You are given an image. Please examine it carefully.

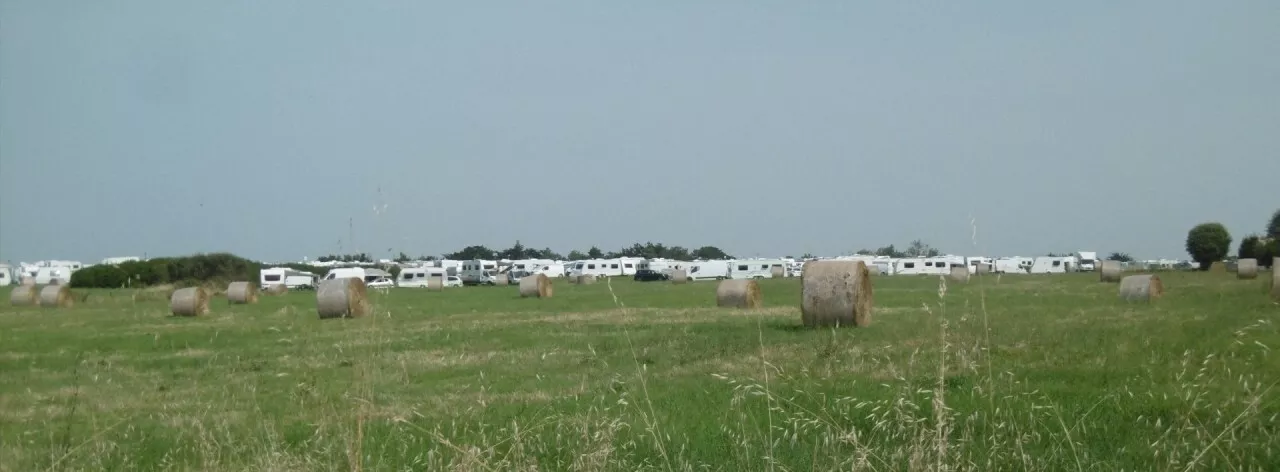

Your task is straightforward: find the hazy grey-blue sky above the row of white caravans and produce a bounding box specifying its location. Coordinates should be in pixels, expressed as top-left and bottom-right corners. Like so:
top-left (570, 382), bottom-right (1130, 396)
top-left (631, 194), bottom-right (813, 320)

top-left (0, 0), bottom-right (1280, 262)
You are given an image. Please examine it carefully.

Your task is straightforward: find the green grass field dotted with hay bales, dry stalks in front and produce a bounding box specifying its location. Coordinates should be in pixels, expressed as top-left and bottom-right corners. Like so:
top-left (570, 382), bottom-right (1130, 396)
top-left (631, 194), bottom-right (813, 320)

top-left (0, 272), bottom-right (1280, 471)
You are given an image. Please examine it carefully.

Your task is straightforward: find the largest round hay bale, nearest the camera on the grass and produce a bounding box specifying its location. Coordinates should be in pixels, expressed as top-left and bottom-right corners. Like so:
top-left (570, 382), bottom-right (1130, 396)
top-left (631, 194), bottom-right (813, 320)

top-left (800, 261), bottom-right (876, 326)
